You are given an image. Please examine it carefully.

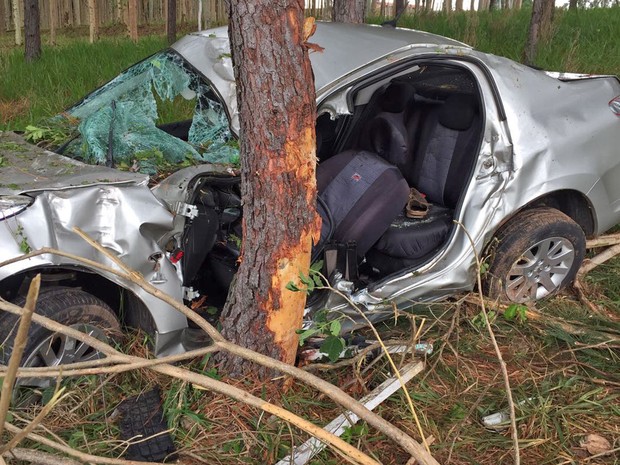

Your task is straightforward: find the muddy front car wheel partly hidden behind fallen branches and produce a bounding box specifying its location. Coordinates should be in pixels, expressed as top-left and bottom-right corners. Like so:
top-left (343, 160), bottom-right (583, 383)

top-left (0, 288), bottom-right (121, 406)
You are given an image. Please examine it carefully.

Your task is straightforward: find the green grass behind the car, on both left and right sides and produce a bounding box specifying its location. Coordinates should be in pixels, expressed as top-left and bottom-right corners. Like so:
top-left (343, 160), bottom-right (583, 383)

top-left (0, 7), bottom-right (620, 130)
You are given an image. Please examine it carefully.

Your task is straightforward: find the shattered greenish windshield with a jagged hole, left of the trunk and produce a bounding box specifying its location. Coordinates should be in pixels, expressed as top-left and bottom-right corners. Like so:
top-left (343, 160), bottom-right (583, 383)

top-left (58, 50), bottom-right (239, 175)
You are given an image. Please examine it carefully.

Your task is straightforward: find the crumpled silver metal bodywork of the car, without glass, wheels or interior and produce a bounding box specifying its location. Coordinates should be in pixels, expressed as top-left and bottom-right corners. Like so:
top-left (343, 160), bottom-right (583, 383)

top-left (0, 23), bottom-right (620, 348)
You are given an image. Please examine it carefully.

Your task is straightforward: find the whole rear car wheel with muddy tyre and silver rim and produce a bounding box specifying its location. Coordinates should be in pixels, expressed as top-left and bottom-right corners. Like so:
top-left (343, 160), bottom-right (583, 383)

top-left (483, 207), bottom-right (586, 303)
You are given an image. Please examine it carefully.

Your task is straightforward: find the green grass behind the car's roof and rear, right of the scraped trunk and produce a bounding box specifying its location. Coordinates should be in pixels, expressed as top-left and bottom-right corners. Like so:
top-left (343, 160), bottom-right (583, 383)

top-left (371, 7), bottom-right (620, 75)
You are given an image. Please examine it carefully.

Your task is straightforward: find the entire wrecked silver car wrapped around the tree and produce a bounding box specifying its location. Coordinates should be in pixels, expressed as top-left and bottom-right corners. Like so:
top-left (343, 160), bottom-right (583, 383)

top-left (0, 23), bottom-right (620, 392)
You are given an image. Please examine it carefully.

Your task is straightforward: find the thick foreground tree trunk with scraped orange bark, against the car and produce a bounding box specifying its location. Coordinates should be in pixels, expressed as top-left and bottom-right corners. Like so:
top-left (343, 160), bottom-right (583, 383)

top-left (217, 0), bottom-right (320, 379)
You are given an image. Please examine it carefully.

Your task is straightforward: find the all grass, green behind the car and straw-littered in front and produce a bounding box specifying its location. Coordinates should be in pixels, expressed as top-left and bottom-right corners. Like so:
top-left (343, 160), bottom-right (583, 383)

top-left (0, 8), bottom-right (620, 465)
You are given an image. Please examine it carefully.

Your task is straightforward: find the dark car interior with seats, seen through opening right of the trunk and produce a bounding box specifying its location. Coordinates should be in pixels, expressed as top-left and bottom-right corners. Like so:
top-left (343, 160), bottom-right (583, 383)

top-left (317, 64), bottom-right (483, 281)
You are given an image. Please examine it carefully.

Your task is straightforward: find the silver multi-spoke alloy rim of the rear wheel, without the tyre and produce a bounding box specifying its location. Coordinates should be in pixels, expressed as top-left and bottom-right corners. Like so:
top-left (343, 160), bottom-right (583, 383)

top-left (506, 237), bottom-right (575, 303)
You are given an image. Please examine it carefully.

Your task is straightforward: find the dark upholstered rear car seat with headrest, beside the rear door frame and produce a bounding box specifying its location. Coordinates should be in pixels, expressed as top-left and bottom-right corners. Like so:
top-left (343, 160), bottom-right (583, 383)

top-left (367, 94), bottom-right (482, 274)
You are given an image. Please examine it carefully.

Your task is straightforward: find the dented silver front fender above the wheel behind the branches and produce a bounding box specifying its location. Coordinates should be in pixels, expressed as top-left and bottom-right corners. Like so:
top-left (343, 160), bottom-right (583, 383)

top-left (0, 184), bottom-right (187, 353)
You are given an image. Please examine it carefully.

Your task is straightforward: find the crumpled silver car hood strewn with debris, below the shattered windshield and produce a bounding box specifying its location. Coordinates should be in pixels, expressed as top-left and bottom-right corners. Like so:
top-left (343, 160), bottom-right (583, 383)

top-left (0, 132), bottom-right (148, 195)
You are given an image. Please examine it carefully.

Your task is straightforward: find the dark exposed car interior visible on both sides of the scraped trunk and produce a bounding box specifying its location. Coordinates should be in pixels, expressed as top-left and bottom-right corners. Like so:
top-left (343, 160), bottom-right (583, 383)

top-left (183, 60), bottom-right (483, 306)
